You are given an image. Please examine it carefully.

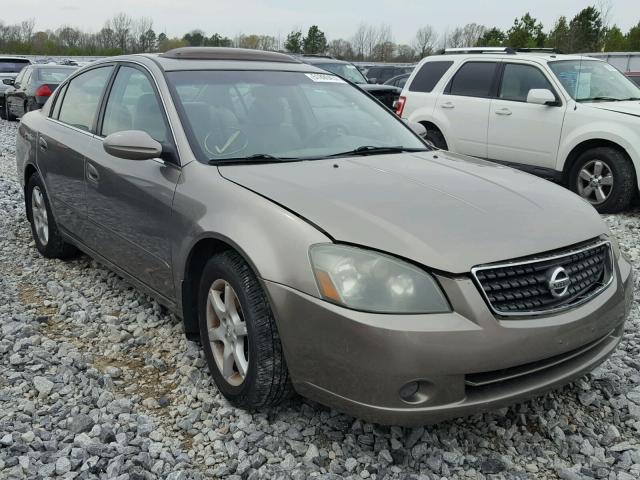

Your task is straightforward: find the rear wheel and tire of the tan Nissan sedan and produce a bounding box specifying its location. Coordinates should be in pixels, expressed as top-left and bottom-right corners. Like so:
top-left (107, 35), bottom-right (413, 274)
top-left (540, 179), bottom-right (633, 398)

top-left (25, 173), bottom-right (78, 258)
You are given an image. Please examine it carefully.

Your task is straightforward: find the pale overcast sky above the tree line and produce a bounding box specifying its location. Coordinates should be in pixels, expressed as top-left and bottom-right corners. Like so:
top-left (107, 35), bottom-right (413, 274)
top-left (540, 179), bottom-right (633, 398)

top-left (1, 0), bottom-right (640, 43)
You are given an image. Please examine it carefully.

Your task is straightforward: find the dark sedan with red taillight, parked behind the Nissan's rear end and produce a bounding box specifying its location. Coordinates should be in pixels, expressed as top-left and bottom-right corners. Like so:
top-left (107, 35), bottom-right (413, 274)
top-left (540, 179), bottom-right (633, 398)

top-left (3, 65), bottom-right (78, 120)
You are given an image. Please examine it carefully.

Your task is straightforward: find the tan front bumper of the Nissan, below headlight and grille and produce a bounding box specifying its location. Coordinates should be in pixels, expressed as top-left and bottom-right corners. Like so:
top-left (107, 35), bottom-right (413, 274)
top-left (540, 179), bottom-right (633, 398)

top-left (265, 258), bottom-right (633, 425)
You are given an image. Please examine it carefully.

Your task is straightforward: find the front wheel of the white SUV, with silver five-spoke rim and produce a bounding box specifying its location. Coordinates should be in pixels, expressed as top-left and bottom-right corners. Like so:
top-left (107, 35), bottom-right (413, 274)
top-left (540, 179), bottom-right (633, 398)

top-left (570, 147), bottom-right (636, 213)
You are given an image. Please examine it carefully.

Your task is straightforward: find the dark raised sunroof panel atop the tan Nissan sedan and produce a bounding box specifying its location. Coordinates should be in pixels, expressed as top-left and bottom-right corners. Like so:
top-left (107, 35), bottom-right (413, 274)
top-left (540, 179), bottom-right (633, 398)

top-left (158, 47), bottom-right (300, 63)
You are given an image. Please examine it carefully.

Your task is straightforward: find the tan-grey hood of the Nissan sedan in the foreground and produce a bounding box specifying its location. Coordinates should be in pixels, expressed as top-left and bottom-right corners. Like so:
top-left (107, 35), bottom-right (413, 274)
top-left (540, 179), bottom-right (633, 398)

top-left (219, 151), bottom-right (608, 273)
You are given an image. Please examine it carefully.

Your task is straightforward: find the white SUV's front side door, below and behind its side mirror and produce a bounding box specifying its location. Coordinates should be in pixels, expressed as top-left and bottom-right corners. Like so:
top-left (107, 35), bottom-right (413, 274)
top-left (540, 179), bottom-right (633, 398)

top-left (488, 62), bottom-right (567, 168)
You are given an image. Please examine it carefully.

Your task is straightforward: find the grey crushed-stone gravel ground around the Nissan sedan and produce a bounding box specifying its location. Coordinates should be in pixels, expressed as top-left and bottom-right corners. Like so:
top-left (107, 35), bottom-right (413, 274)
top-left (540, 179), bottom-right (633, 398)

top-left (0, 117), bottom-right (640, 480)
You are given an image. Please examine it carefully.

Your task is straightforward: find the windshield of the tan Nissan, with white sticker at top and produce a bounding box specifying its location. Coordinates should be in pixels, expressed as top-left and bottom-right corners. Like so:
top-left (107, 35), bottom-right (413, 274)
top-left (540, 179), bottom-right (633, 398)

top-left (168, 70), bottom-right (427, 161)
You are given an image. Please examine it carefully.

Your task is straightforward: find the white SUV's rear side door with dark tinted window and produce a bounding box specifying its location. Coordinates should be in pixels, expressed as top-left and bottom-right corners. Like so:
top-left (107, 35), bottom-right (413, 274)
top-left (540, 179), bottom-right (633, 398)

top-left (433, 60), bottom-right (498, 158)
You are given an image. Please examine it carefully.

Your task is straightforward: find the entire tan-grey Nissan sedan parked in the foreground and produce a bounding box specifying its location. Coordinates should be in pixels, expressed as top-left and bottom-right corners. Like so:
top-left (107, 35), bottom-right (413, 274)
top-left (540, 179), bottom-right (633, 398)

top-left (16, 48), bottom-right (632, 425)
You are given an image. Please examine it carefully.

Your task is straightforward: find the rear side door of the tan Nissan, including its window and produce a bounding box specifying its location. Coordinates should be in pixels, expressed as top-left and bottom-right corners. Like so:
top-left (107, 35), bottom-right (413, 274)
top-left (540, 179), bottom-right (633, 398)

top-left (37, 66), bottom-right (113, 240)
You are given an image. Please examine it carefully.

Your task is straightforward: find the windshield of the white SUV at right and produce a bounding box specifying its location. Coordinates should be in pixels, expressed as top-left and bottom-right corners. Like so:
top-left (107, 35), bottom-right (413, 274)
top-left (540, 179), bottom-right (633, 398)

top-left (549, 60), bottom-right (640, 102)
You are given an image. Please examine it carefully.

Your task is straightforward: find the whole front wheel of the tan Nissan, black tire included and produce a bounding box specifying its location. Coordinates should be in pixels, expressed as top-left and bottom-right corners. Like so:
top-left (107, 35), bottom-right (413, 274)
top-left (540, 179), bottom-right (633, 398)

top-left (198, 251), bottom-right (290, 408)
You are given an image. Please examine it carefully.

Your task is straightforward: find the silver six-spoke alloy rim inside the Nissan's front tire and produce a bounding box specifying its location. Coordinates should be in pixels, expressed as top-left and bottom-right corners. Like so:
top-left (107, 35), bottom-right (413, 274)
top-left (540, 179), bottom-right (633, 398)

top-left (207, 279), bottom-right (249, 386)
